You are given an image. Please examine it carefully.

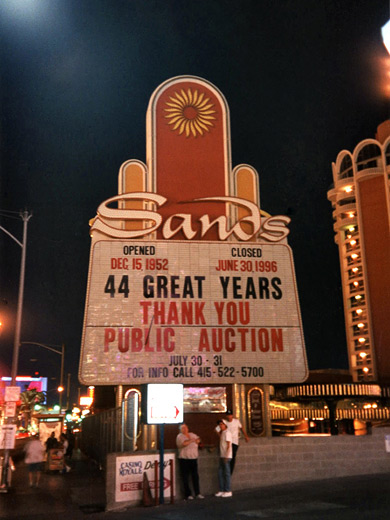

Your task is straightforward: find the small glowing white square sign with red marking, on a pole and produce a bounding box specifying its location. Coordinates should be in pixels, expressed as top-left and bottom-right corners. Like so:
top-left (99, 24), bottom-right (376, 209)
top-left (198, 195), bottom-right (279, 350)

top-left (146, 384), bottom-right (184, 424)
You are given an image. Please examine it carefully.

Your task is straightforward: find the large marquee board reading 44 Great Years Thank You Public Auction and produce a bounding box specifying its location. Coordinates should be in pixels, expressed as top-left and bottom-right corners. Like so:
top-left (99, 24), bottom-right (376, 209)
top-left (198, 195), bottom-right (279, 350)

top-left (80, 239), bottom-right (307, 385)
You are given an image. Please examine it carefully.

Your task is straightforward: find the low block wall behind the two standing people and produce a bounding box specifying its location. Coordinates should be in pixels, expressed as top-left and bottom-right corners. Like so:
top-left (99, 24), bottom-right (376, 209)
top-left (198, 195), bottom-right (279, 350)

top-left (106, 428), bottom-right (390, 509)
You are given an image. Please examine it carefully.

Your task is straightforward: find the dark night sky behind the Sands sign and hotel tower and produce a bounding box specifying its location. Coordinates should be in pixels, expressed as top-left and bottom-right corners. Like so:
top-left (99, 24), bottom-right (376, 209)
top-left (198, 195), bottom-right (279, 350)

top-left (0, 0), bottom-right (390, 404)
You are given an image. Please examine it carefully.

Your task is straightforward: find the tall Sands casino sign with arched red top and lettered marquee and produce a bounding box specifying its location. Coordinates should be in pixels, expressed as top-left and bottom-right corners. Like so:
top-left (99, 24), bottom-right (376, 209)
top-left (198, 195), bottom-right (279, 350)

top-left (79, 76), bottom-right (307, 385)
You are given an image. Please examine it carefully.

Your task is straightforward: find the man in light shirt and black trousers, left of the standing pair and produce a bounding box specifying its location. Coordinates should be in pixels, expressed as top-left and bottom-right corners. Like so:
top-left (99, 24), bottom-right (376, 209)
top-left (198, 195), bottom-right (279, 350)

top-left (176, 423), bottom-right (204, 500)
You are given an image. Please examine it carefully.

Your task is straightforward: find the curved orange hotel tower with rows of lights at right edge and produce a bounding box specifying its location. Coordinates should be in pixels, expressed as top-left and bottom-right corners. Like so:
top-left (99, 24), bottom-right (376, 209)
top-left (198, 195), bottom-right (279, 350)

top-left (328, 120), bottom-right (390, 384)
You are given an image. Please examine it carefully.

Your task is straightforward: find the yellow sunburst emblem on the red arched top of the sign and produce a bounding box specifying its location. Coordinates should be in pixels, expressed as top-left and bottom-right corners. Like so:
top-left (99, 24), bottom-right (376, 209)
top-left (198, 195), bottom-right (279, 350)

top-left (164, 88), bottom-right (216, 137)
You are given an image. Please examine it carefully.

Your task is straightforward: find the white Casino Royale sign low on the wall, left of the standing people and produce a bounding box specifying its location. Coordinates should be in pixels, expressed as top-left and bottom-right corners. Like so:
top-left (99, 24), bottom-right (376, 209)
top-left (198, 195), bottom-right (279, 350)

top-left (115, 453), bottom-right (175, 502)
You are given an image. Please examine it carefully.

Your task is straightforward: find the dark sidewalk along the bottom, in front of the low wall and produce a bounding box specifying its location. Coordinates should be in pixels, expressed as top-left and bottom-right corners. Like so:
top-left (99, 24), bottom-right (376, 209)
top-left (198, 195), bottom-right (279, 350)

top-left (0, 451), bottom-right (390, 520)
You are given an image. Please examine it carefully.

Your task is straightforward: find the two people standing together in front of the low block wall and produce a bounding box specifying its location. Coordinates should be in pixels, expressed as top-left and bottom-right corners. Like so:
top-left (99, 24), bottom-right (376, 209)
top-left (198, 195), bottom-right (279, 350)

top-left (176, 410), bottom-right (249, 500)
